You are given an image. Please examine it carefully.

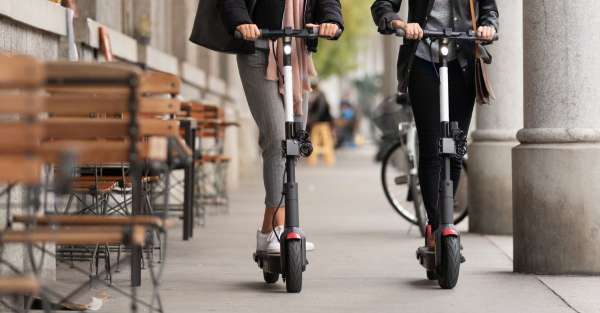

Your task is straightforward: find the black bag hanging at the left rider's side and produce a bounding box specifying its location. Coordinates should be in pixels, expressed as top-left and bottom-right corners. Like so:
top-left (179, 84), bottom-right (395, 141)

top-left (190, 0), bottom-right (254, 54)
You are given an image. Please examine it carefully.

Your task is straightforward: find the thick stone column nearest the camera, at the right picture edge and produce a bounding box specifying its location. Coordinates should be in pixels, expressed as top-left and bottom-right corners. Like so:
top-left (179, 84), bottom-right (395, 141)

top-left (513, 0), bottom-right (600, 274)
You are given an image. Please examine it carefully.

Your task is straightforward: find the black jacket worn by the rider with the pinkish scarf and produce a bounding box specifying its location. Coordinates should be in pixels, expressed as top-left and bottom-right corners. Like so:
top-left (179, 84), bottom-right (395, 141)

top-left (222, 0), bottom-right (344, 52)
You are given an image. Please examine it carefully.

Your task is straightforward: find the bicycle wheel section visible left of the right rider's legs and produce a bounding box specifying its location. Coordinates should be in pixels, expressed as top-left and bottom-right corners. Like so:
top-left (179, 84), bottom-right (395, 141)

top-left (381, 142), bottom-right (418, 225)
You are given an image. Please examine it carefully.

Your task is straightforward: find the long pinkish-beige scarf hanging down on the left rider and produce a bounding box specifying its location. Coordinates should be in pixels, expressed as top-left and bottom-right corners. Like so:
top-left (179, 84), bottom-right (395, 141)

top-left (266, 0), bottom-right (317, 116)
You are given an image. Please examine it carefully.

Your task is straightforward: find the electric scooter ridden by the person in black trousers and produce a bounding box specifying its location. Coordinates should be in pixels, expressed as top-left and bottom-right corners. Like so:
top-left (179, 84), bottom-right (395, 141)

top-left (396, 29), bottom-right (498, 289)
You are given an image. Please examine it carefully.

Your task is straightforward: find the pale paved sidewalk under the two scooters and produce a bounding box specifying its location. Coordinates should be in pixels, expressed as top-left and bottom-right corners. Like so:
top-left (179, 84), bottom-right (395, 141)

top-left (83, 146), bottom-right (600, 313)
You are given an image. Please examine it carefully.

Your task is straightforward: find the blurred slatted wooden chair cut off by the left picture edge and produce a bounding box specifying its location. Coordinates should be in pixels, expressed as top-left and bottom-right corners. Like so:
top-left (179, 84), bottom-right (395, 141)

top-left (0, 55), bottom-right (145, 308)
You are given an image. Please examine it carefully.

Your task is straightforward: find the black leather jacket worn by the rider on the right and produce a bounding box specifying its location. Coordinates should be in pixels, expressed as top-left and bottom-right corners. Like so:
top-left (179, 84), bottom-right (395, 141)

top-left (371, 0), bottom-right (499, 92)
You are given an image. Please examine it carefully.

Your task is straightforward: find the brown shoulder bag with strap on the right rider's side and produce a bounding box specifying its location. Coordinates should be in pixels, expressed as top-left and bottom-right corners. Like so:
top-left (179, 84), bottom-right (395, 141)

top-left (469, 0), bottom-right (496, 105)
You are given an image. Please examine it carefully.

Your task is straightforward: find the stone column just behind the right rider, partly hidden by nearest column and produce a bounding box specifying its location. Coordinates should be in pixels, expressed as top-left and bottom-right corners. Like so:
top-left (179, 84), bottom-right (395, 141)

top-left (468, 0), bottom-right (523, 234)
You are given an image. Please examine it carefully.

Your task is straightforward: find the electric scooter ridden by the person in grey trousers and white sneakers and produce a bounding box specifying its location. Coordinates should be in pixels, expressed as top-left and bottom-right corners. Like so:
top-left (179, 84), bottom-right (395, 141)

top-left (235, 28), bottom-right (339, 293)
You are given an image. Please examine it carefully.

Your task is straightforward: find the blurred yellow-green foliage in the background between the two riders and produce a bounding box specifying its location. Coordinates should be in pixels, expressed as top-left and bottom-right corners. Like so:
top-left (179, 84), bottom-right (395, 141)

top-left (314, 0), bottom-right (374, 78)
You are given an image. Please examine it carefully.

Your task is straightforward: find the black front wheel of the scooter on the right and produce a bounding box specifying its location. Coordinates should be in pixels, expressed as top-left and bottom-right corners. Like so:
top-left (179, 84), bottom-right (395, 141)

top-left (437, 237), bottom-right (460, 289)
